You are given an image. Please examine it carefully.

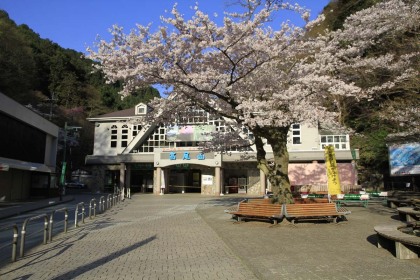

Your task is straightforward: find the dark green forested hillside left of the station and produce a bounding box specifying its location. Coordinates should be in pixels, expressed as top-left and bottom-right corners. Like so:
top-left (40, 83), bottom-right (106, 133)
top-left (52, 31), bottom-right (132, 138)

top-left (0, 10), bottom-right (159, 169)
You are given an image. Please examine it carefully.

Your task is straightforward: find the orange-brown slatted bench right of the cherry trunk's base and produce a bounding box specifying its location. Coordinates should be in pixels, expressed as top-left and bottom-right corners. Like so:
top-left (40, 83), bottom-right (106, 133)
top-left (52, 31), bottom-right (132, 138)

top-left (284, 203), bottom-right (351, 223)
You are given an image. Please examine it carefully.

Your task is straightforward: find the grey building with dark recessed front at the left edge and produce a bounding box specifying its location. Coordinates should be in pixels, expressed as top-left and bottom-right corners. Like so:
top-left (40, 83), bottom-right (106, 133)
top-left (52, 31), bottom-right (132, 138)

top-left (0, 93), bottom-right (59, 201)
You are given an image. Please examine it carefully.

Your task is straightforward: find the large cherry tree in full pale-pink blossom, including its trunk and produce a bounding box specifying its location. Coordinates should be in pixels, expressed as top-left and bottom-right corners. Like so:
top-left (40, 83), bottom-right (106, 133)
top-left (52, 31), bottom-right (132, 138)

top-left (88, 0), bottom-right (420, 203)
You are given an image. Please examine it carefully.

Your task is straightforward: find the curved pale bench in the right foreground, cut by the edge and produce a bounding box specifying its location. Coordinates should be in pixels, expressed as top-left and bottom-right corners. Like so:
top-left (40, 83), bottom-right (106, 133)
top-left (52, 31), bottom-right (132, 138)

top-left (374, 225), bottom-right (420, 260)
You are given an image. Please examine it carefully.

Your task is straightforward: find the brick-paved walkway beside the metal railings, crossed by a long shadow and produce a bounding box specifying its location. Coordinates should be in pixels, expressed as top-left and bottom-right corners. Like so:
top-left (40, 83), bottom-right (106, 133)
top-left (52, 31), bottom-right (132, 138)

top-left (0, 195), bottom-right (257, 279)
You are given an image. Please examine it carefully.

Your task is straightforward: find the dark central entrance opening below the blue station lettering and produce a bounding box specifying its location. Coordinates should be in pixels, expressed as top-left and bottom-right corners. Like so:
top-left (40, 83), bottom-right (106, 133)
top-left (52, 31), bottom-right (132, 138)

top-left (169, 169), bottom-right (201, 193)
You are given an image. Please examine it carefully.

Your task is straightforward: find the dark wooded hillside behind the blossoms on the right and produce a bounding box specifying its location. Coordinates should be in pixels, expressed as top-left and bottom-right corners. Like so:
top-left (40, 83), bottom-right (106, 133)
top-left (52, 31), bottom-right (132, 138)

top-left (312, 0), bottom-right (420, 185)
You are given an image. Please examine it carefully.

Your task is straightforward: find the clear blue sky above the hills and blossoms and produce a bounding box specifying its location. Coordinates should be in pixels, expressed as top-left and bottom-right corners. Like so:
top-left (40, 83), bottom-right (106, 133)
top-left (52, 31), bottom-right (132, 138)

top-left (0, 0), bottom-right (329, 52)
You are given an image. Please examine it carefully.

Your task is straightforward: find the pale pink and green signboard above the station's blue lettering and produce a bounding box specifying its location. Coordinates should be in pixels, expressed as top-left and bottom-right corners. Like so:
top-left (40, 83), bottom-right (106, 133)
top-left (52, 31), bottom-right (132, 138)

top-left (166, 125), bottom-right (216, 142)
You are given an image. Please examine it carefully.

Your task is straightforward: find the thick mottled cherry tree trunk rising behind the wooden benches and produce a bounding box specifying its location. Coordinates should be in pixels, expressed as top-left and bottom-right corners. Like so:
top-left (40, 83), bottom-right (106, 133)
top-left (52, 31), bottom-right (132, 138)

top-left (254, 127), bottom-right (293, 204)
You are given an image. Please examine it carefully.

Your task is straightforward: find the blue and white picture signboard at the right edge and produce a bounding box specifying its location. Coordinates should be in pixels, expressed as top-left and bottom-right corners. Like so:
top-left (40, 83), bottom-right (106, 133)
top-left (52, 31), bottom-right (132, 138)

top-left (388, 143), bottom-right (420, 176)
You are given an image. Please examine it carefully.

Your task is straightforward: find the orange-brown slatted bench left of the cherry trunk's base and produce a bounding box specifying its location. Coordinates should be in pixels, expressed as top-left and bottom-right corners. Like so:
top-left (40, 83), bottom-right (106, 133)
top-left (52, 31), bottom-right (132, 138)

top-left (229, 201), bottom-right (283, 224)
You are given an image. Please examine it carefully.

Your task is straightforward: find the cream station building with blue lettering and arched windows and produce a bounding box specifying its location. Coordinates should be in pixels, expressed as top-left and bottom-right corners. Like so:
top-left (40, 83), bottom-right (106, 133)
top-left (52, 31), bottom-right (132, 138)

top-left (86, 103), bottom-right (358, 195)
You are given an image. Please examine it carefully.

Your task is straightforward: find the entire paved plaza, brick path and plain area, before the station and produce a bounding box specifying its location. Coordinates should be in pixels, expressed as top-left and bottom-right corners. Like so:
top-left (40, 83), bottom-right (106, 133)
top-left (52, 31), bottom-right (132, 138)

top-left (0, 194), bottom-right (420, 279)
